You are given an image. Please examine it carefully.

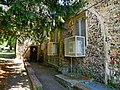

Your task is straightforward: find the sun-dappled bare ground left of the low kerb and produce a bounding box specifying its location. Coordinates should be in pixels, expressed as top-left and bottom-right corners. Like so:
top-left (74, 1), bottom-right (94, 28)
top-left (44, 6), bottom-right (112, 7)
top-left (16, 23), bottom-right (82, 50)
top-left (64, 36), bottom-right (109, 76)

top-left (0, 59), bottom-right (32, 90)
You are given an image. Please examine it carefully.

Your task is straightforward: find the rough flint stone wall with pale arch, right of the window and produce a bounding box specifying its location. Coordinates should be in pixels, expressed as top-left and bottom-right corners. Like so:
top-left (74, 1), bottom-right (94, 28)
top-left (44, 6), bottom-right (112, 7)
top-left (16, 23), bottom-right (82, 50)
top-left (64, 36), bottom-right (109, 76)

top-left (63, 0), bottom-right (120, 83)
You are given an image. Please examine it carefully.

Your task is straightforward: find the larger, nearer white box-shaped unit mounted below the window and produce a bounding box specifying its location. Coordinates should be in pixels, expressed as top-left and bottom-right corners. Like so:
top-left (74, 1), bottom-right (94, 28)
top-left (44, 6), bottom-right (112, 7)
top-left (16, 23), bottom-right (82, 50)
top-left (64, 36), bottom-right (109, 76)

top-left (65, 36), bottom-right (85, 57)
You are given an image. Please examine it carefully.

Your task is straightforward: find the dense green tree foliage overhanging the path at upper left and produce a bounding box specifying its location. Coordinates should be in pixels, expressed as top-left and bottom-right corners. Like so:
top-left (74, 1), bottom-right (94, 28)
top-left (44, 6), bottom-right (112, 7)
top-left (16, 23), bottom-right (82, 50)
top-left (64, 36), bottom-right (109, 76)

top-left (0, 0), bottom-right (85, 42)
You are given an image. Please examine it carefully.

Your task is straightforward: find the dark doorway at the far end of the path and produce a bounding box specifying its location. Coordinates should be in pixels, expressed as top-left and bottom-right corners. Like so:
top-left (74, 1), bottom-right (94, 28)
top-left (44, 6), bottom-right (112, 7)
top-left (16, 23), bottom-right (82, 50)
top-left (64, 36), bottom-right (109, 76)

top-left (30, 46), bottom-right (37, 62)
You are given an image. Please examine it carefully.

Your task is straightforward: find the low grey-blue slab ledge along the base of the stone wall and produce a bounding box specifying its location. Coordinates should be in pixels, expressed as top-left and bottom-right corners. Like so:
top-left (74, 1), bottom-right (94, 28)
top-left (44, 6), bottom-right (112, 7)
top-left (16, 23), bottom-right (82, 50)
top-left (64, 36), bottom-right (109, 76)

top-left (55, 74), bottom-right (115, 90)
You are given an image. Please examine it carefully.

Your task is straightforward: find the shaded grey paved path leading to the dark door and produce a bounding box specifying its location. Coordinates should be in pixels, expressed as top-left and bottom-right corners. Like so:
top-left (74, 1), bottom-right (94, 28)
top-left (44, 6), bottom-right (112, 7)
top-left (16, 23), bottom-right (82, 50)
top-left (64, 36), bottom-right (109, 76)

top-left (30, 63), bottom-right (67, 90)
